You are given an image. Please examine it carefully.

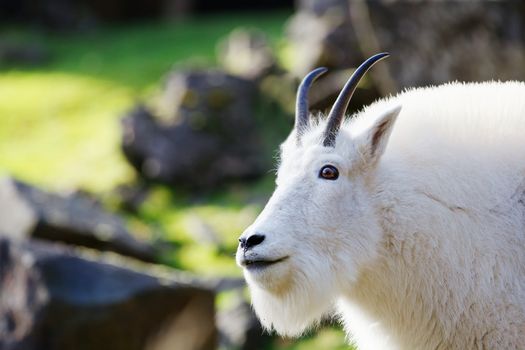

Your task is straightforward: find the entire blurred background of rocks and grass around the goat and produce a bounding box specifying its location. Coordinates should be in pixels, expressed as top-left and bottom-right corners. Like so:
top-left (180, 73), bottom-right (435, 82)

top-left (0, 0), bottom-right (525, 350)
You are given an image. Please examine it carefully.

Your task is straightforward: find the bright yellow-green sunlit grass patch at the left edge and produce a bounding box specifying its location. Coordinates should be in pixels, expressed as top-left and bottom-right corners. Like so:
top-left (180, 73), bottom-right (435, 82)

top-left (0, 72), bottom-right (133, 191)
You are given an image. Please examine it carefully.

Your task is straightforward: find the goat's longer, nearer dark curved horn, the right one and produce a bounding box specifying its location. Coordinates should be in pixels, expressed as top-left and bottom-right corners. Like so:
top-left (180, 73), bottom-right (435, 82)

top-left (323, 52), bottom-right (390, 147)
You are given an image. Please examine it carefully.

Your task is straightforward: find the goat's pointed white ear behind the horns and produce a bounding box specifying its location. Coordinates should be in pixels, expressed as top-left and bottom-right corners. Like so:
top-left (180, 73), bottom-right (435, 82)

top-left (358, 106), bottom-right (401, 166)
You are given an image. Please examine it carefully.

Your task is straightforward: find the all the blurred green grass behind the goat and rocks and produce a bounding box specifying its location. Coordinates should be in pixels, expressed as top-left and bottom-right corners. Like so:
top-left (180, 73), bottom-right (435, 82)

top-left (0, 13), bottom-right (352, 350)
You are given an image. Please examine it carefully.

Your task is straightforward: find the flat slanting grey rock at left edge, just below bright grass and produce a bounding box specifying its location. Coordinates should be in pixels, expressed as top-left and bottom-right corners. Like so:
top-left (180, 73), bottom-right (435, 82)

top-left (0, 178), bottom-right (155, 261)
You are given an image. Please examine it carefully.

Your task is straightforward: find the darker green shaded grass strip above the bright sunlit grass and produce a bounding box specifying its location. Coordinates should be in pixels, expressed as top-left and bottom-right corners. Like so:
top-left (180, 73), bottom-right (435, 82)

top-left (2, 12), bottom-right (290, 90)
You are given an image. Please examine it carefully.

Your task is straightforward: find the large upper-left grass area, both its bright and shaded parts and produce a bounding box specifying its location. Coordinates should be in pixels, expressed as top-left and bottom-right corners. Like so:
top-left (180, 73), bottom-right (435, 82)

top-left (0, 13), bottom-right (288, 192)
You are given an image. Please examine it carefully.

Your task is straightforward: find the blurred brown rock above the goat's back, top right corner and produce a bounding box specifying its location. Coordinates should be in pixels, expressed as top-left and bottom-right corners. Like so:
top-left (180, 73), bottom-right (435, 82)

top-left (357, 1), bottom-right (525, 89)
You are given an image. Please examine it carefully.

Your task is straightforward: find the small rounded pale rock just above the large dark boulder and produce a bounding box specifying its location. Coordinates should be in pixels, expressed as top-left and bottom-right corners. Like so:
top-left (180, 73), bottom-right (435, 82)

top-left (217, 29), bottom-right (276, 80)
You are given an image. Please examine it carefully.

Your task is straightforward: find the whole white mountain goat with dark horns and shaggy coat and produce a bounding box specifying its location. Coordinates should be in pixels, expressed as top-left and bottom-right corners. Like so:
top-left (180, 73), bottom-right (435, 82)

top-left (236, 54), bottom-right (525, 350)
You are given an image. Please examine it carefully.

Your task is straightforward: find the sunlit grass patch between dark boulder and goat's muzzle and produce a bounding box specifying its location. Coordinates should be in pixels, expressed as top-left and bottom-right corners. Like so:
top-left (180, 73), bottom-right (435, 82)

top-left (139, 185), bottom-right (272, 276)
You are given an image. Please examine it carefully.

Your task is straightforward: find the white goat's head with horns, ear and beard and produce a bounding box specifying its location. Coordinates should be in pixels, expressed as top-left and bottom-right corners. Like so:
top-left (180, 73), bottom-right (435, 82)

top-left (237, 53), bottom-right (400, 336)
